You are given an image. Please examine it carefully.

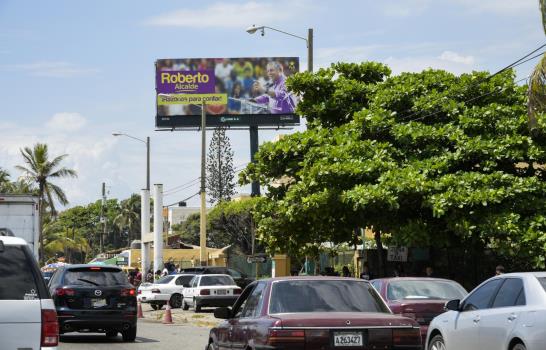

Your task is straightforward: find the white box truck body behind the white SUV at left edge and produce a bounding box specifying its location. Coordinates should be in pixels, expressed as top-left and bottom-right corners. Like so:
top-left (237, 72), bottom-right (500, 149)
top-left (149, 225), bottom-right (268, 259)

top-left (0, 193), bottom-right (40, 259)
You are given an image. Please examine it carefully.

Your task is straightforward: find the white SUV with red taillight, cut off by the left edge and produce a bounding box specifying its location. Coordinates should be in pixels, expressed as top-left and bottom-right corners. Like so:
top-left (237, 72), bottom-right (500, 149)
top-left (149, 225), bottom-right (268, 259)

top-left (0, 234), bottom-right (59, 350)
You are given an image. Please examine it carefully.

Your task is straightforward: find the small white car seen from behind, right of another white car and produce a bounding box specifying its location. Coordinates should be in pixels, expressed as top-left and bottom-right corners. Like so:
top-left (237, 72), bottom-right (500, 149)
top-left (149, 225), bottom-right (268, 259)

top-left (182, 274), bottom-right (242, 312)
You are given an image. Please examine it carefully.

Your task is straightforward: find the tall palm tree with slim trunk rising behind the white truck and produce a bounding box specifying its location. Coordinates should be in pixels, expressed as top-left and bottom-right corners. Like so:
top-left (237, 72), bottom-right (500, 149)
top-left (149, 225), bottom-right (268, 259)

top-left (16, 143), bottom-right (77, 263)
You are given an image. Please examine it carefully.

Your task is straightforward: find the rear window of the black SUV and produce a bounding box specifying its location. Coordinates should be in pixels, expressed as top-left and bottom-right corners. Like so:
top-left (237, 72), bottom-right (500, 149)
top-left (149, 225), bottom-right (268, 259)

top-left (64, 267), bottom-right (128, 286)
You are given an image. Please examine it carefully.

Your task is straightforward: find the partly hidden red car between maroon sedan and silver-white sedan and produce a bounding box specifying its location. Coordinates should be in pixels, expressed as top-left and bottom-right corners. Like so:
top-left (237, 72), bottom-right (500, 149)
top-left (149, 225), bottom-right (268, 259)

top-left (370, 277), bottom-right (468, 344)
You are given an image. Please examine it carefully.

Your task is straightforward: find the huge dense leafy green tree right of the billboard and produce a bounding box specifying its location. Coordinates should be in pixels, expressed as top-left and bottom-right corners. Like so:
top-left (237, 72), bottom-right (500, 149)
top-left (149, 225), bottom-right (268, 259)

top-left (241, 62), bottom-right (546, 267)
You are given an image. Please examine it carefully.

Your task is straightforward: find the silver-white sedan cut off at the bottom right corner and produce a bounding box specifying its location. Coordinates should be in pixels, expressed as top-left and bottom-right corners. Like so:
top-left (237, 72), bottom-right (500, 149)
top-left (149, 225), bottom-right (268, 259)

top-left (427, 272), bottom-right (546, 350)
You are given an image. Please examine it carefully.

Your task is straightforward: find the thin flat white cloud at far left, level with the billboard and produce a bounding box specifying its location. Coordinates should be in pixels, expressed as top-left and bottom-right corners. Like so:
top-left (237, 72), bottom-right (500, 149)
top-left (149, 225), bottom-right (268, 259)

top-left (3, 62), bottom-right (99, 78)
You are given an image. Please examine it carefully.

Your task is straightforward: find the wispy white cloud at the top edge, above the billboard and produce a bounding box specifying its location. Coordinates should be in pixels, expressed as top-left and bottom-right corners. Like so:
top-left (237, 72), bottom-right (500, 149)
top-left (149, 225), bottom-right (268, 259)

top-left (145, 0), bottom-right (317, 28)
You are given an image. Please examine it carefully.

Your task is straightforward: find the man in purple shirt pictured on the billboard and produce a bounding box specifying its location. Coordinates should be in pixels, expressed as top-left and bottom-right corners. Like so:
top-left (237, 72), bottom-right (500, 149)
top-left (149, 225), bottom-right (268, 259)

top-left (250, 61), bottom-right (297, 114)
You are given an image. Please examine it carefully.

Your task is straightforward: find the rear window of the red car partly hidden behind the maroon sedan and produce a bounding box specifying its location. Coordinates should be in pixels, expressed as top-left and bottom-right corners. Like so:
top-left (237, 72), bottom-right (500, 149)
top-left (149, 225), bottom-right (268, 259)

top-left (387, 280), bottom-right (467, 300)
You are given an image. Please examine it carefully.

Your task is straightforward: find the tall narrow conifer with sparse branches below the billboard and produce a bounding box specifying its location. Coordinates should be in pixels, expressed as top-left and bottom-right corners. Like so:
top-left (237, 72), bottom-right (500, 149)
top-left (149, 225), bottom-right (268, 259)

top-left (207, 127), bottom-right (235, 203)
